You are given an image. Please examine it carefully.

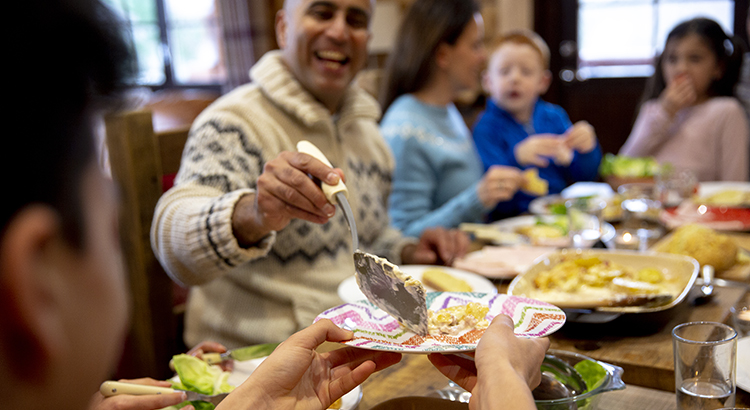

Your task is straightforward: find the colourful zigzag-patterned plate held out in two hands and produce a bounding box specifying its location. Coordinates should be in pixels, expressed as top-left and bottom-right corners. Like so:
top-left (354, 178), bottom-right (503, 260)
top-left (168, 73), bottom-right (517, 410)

top-left (315, 292), bottom-right (565, 353)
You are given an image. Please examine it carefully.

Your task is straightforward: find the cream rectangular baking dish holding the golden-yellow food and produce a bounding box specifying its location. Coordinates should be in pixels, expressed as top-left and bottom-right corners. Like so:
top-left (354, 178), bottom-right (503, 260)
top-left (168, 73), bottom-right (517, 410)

top-left (508, 249), bottom-right (699, 313)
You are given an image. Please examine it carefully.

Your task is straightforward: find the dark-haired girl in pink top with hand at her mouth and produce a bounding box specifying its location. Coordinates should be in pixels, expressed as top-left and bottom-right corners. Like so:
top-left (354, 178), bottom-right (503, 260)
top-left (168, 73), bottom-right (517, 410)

top-left (620, 18), bottom-right (750, 181)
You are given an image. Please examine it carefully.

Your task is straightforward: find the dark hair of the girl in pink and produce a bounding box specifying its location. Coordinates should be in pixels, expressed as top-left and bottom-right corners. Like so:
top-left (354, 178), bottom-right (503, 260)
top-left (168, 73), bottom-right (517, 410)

top-left (641, 17), bottom-right (745, 103)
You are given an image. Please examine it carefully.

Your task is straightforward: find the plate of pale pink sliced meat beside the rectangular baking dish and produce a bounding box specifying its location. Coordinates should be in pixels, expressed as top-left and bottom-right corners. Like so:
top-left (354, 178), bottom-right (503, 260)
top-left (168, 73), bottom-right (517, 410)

top-left (453, 245), bottom-right (557, 279)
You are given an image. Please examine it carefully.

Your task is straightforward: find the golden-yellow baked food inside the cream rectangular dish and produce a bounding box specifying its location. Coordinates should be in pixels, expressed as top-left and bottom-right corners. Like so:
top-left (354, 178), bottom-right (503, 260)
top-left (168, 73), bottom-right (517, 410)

top-left (525, 256), bottom-right (680, 307)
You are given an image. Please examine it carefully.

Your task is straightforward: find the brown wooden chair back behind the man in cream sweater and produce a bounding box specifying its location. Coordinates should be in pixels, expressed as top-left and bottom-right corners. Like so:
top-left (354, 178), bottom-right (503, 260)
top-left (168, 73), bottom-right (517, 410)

top-left (105, 111), bottom-right (194, 379)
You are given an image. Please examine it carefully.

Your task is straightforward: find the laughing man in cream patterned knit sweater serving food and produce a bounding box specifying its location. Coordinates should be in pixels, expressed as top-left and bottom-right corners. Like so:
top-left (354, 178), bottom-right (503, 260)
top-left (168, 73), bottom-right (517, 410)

top-left (151, 0), bottom-right (468, 348)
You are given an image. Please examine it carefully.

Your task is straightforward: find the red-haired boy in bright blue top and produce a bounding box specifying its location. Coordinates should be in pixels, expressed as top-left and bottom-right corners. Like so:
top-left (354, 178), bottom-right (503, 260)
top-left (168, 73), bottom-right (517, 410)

top-left (474, 30), bottom-right (602, 220)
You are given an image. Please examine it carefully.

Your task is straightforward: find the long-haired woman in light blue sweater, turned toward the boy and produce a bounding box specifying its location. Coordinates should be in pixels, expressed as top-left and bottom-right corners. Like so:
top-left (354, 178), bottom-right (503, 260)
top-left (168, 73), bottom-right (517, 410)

top-left (380, 0), bottom-right (521, 236)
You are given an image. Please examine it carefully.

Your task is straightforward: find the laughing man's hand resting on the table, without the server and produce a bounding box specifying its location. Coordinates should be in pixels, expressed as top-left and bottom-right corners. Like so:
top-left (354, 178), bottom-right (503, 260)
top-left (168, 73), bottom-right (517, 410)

top-left (401, 228), bottom-right (470, 266)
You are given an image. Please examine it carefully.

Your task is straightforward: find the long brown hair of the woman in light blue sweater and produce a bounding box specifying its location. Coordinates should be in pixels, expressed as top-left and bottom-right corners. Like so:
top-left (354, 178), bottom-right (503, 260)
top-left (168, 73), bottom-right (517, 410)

top-left (380, 0), bottom-right (479, 112)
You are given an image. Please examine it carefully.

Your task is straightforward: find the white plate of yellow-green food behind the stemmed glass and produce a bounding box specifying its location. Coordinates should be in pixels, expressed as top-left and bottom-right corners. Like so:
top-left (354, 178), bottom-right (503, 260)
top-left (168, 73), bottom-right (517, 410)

top-left (492, 215), bottom-right (615, 247)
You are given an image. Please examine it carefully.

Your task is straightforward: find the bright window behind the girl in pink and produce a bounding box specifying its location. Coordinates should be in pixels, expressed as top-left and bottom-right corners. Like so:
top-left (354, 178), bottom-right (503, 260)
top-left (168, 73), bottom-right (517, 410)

top-left (576, 0), bottom-right (734, 79)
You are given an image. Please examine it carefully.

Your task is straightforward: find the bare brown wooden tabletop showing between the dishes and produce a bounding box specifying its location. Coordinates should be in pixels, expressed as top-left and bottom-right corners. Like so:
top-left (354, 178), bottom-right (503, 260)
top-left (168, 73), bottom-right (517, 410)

top-left (346, 233), bottom-right (750, 410)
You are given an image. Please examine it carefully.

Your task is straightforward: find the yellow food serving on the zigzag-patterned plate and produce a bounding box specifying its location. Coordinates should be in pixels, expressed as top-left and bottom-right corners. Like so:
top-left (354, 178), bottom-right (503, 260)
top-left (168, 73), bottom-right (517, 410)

top-left (427, 302), bottom-right (490, 336)
